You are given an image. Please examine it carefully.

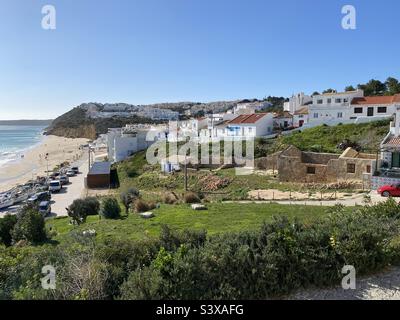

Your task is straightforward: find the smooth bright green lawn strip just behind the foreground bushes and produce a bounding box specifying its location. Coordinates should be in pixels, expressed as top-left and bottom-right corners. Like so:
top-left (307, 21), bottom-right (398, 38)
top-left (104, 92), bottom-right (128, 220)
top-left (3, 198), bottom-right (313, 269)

top-left (47, 203), bottom-right (338, 242)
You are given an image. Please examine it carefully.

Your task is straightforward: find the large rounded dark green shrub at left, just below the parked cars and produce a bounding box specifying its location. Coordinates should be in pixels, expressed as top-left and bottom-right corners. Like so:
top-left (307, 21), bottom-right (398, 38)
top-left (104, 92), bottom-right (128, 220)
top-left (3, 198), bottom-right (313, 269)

top-left (11, 208), bottom-right (47, 243)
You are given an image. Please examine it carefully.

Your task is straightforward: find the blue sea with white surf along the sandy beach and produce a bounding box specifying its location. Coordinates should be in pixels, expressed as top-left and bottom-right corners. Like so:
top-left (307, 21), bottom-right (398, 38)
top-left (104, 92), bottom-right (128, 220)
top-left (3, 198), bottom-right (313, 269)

top-left (0, 125), bottom-right (45, 167)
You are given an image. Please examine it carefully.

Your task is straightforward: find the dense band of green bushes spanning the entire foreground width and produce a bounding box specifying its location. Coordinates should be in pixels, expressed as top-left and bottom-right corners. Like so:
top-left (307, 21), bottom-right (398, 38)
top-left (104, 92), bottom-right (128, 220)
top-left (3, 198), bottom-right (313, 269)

top-left (0, 199), bottom-right (400, 300)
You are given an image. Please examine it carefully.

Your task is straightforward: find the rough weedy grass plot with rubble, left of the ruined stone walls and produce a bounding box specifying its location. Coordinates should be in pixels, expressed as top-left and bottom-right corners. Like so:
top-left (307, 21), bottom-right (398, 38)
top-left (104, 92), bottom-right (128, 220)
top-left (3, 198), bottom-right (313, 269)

top-left (116, 152), bottom-right (362, 201)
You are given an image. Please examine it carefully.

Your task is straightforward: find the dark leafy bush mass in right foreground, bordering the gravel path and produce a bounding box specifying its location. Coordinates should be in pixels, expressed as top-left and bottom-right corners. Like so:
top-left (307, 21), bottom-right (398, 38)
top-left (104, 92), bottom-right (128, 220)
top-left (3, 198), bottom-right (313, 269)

top-left (121, 202), bottom-right (400, 300)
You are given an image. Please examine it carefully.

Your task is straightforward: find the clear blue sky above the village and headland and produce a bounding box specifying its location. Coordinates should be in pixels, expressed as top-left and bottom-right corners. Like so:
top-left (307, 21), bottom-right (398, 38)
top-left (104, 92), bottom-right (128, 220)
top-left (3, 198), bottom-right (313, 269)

top-left (0, 0), bottom-right (400, 119)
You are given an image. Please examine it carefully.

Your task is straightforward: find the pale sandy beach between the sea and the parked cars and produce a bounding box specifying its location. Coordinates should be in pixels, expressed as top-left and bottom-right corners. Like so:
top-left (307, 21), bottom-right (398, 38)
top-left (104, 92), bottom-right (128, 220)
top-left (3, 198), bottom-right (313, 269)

top-left (0, 136), bottom-right (88, 192)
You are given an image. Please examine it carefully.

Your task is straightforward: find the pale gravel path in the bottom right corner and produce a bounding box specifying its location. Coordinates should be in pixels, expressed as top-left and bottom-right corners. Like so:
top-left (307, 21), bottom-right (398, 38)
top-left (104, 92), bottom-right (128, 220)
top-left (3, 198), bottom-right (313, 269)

top-left (289, 267), bottom-right (400, 300)
